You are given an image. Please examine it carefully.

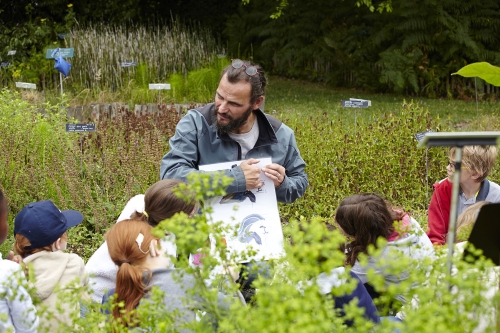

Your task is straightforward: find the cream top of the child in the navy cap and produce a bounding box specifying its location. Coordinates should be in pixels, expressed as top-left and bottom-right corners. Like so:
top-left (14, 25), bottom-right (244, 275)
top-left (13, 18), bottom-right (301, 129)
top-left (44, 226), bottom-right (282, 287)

top-left (24, 251), bottom-right (88, 332)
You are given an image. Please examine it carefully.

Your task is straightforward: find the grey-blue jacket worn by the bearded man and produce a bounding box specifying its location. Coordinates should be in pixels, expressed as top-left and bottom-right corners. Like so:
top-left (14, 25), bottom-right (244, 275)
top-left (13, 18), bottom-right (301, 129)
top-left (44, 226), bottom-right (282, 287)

top-left (160, 103), bottom-right (309, 202)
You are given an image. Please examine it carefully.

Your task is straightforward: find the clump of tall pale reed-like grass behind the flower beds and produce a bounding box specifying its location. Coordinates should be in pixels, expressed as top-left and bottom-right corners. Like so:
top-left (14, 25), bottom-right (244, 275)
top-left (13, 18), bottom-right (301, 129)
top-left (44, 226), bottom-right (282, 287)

top-left (69, 20), bottom-right (223, 91)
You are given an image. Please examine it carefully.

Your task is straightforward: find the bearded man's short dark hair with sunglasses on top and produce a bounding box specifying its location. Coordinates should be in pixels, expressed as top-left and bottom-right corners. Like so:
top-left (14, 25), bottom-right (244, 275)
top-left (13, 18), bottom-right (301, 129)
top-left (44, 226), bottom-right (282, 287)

top-left (221, 61), bottom-right (267, 103)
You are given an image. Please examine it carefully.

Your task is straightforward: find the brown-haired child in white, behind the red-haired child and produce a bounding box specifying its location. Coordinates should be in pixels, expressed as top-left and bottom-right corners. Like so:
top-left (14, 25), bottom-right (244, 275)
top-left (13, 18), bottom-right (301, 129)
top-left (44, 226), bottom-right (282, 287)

top-left (86, 179), bottom-right (197, 303)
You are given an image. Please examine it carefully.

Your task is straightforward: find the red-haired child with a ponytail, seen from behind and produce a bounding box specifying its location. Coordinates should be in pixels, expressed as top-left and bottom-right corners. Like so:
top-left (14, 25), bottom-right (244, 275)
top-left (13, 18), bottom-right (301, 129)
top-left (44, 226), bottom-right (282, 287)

top-left (103, 220), bottom-right (228, 332)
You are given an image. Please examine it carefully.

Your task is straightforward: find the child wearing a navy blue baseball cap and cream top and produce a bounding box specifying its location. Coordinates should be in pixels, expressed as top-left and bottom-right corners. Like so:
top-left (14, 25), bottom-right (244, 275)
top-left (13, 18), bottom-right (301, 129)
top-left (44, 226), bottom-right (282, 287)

top-left (14, 200), bottom-right (87, 332)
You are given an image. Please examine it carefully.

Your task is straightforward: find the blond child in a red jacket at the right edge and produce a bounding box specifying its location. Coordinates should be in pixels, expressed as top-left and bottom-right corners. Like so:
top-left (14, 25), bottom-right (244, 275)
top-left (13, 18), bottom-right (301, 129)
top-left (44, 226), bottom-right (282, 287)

top-left (427, 146), bottom-right (500, 245)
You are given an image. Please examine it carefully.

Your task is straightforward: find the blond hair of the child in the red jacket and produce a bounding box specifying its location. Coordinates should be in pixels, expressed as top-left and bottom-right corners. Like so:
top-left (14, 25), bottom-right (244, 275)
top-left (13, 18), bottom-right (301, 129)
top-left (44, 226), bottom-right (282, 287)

top-left (449, 146), bottom-right (498, 183)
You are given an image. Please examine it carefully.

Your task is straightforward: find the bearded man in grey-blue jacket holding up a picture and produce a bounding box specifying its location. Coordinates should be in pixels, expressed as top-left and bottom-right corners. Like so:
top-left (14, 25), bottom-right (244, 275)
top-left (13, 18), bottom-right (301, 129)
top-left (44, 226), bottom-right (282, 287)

top-left (160, 59), bottom-right (308, 202)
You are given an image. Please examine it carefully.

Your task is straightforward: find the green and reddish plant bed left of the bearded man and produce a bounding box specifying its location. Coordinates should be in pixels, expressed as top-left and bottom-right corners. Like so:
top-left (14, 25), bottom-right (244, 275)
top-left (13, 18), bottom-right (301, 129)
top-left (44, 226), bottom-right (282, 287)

top-left (0, 89), bottom-right (179, 258)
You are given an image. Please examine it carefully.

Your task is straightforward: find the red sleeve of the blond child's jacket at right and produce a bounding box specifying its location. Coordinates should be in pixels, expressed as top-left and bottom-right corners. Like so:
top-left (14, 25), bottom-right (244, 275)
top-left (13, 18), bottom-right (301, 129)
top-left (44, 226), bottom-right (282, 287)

top-left (427, 178), bottom-right (453, 245)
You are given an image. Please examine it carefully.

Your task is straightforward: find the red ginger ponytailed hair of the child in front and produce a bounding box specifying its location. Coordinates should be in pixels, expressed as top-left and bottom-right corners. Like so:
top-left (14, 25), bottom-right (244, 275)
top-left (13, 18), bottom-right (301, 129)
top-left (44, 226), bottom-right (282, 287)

top-left (104, 220), bottom-right (158, 326)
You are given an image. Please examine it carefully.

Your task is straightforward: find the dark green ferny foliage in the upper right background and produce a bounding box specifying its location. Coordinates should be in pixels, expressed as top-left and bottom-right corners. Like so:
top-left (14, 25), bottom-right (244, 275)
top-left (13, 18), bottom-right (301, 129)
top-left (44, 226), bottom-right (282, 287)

top-left (226, 0), bottom-right (500, 97)
